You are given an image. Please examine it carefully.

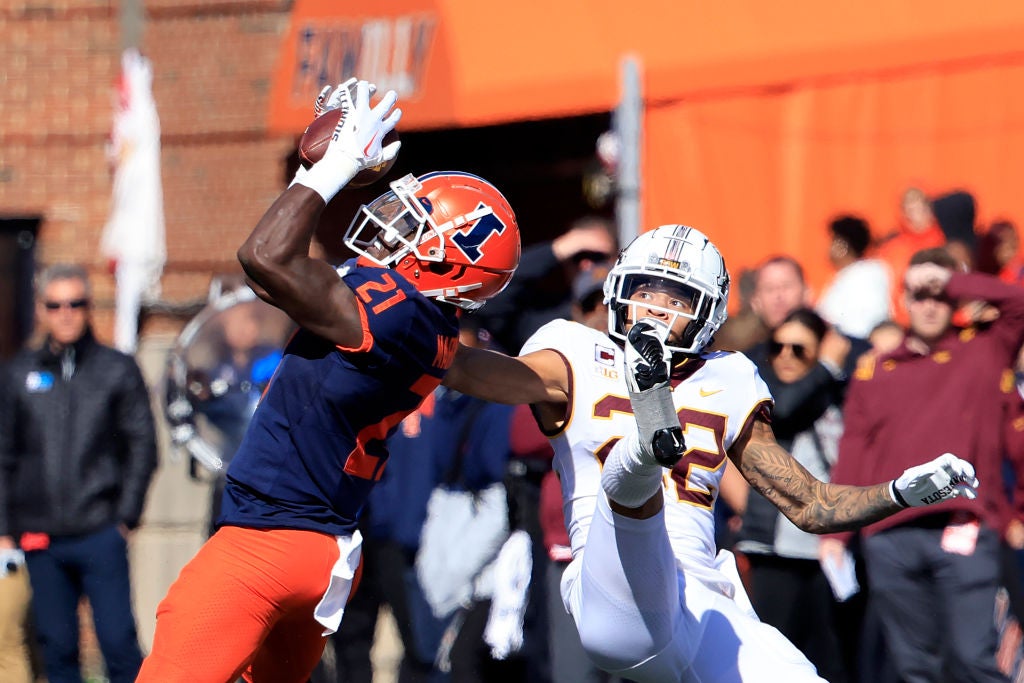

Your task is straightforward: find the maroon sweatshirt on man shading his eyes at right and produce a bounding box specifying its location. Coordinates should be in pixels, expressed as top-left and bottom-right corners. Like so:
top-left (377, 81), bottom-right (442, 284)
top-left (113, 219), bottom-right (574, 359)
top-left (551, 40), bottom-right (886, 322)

top-left (831, 273), bottom-right (1024, 541)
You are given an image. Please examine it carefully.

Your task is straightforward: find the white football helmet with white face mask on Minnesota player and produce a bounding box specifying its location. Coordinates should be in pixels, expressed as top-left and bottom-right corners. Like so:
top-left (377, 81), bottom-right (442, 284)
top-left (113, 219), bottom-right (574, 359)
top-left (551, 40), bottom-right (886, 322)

top-left (604, 225), bottom-right (729, 354)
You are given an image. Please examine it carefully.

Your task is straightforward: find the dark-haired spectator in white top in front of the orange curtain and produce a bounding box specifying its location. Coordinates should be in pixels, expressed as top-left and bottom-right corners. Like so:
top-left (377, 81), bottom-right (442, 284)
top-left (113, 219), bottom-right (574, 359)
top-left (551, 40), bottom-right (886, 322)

top-left (817, 215), bottom-right (892, 339)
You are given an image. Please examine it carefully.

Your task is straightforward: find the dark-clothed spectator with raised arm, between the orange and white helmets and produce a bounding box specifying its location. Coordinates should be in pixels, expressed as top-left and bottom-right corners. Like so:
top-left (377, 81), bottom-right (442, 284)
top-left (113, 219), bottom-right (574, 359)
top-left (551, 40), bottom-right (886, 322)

top-left (478, 216), bottom-right (617, 353)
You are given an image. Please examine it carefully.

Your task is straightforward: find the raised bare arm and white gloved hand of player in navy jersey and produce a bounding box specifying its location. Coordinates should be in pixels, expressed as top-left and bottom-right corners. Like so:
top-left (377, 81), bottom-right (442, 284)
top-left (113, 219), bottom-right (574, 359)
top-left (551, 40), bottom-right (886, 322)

top-left (238, 80), bottom-right (401, 346)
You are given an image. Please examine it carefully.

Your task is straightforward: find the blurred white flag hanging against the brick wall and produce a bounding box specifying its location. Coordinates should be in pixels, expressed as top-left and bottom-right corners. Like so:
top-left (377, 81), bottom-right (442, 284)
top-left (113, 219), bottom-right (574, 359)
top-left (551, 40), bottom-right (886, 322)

top-left (99, 48), bottom-right (167, 353)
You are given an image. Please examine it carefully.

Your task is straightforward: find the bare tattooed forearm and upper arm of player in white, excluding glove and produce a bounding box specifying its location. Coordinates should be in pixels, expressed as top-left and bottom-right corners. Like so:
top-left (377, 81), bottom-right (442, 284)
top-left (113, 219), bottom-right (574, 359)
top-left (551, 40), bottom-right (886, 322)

top-left (733, 420), bottom-right (901, 533)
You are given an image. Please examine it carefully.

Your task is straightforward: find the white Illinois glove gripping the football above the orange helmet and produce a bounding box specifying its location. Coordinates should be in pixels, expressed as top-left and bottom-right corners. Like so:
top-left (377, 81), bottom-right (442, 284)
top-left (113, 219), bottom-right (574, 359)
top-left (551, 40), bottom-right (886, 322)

top-left (292, 78), bottom-right (401, 202)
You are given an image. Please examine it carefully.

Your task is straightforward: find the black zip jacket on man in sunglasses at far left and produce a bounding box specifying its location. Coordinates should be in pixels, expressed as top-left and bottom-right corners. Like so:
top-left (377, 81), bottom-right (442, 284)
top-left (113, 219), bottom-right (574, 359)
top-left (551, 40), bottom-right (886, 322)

top-left (0, 332), bottom-right (157, 536)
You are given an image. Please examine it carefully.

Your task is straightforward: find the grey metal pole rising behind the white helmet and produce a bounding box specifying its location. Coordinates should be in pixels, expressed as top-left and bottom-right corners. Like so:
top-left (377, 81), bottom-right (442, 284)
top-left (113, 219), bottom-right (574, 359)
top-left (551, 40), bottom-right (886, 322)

top-left (612, 56), bottom-right (643, 247)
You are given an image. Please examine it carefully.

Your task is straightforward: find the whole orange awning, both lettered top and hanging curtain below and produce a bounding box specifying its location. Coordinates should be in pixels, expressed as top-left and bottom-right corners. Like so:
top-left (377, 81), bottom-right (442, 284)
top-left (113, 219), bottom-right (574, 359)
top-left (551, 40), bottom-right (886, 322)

top-left (269, 0), bottom-right (1024, 305)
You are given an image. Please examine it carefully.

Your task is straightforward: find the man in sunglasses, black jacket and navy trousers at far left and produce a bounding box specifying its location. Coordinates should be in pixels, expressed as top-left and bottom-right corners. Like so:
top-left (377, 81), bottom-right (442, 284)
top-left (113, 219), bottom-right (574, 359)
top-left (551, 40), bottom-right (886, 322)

top-left (0, 264), bottom-right (157, 683)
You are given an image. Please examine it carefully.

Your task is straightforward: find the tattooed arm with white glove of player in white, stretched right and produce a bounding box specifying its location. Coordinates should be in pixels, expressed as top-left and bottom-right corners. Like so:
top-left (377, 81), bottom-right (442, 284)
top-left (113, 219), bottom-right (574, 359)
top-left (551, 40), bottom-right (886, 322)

top-left (729, 420), bottom-right (978, 533)
